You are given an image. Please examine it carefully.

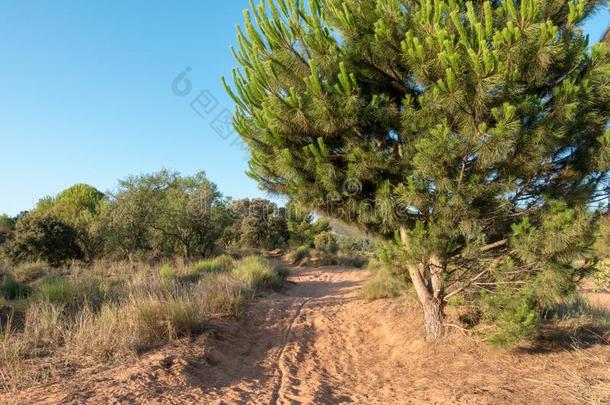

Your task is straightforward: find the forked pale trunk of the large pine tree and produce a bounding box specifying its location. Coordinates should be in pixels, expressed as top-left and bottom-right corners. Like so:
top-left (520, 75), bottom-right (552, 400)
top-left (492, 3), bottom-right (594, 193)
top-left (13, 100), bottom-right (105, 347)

top-left (400, 227), bottom-right (446, 341)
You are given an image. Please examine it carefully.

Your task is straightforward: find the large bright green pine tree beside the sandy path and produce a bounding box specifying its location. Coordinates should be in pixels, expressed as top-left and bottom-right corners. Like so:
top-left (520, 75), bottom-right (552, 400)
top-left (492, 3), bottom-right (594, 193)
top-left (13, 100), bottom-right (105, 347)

top-left (225, 0), bottom-right (610, 341)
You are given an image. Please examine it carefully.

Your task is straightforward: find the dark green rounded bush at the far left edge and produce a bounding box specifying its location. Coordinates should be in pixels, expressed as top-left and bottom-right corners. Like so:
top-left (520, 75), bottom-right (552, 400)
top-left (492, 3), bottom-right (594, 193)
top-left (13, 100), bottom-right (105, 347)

top-left (5, 212), bottom-right (82, 266)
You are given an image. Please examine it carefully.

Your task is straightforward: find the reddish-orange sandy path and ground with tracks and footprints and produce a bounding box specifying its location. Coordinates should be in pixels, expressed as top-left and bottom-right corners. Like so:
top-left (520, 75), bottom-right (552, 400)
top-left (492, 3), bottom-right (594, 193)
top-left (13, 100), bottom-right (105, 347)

top-left (5, 267), bottom-right (610, 404)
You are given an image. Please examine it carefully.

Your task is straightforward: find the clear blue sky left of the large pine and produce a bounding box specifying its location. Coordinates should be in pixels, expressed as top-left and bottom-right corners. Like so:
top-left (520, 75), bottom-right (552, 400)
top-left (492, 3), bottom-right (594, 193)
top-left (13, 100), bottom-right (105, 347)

top-left (0, 0), bottom-right (610, 215)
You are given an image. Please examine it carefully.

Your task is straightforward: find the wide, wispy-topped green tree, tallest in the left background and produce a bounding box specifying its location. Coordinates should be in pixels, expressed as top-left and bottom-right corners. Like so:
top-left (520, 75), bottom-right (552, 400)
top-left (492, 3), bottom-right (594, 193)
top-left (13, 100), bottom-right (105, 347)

top-left (109, 170), bottom-right (233, 257)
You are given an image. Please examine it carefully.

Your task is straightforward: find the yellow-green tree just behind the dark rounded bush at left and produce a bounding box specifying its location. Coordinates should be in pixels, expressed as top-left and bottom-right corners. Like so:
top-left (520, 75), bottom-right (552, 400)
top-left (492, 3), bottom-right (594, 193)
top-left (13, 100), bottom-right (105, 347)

top-left (36, 184), bottom-right (107, 261)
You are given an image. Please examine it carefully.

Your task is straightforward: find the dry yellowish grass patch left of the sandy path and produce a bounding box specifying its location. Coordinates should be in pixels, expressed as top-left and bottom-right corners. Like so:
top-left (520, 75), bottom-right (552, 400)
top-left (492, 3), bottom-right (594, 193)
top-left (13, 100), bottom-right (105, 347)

top-left (0, 257), bottom-right (282, 392)
